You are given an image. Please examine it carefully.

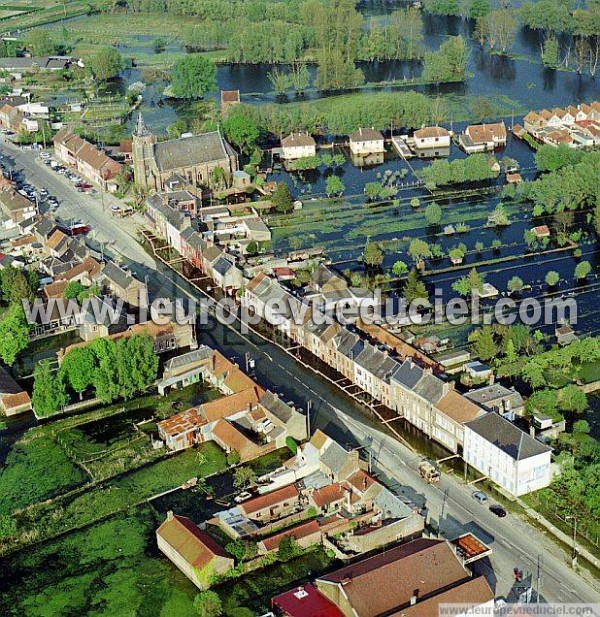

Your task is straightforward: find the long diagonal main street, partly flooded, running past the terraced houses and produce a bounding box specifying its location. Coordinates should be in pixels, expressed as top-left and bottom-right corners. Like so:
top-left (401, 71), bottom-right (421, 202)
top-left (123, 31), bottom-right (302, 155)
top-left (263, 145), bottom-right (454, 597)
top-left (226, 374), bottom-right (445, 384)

top-left (5, 140), bottom-right (598, 602)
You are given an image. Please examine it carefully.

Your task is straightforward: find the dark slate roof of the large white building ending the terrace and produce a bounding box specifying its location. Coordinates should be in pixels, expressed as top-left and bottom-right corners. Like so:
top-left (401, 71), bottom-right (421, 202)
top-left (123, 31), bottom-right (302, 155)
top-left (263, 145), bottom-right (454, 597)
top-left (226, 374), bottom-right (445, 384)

top-left (465, 411), bottom-right (552, 461)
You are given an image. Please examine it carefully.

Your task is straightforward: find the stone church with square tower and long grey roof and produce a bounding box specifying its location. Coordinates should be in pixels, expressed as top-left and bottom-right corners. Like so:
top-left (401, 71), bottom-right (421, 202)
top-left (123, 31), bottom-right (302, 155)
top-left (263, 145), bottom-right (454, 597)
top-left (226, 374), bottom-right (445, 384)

top-left (132, 113), bottom-right (238, 191)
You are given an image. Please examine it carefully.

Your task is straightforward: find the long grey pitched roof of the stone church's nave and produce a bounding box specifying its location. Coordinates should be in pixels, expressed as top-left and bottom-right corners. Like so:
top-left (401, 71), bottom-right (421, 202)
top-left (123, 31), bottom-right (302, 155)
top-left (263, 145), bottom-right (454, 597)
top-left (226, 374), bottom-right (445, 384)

top-left (154, 131), bottom-right (229, 172)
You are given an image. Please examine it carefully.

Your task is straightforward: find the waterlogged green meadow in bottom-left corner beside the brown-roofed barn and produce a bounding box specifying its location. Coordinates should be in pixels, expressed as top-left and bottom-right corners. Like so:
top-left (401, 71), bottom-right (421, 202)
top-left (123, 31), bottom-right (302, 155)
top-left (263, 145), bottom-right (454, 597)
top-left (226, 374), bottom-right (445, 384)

top-left (0, 506), bottom-right (197, 617)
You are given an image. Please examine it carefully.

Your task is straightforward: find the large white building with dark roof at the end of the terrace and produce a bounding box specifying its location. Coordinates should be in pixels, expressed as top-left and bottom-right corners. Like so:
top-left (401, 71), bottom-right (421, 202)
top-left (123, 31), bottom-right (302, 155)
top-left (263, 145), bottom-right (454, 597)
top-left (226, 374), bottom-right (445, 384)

top-left (463, 412), bottom-right (552, 497)
